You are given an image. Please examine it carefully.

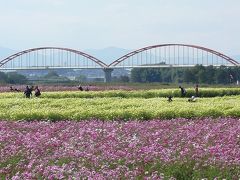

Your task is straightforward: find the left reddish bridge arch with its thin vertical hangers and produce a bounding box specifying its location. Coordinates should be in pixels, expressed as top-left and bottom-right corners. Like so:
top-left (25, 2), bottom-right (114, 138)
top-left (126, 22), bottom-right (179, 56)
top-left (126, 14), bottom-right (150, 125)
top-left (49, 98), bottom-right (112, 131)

top-left (0, 47), bottom-right (108, 69)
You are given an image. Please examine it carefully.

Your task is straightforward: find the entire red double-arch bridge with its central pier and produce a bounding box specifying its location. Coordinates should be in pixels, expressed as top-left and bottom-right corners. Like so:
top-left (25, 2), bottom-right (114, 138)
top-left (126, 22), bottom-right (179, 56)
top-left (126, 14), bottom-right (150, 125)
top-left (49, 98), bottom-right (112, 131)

top-left (0, 44), bottom-right (239, 81)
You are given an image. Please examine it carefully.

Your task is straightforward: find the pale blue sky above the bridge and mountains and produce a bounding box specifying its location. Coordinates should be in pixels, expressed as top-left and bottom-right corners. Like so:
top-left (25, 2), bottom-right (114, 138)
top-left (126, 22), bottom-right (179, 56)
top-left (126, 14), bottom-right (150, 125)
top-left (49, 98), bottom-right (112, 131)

top-left (0, 0), bottom-right (240, 55)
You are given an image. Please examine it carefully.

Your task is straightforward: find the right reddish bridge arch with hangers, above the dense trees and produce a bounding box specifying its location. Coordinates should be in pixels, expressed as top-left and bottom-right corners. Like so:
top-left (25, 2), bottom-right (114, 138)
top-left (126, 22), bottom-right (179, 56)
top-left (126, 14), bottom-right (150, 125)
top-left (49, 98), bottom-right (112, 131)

top-left (109, 44), bottom-right (239, 68)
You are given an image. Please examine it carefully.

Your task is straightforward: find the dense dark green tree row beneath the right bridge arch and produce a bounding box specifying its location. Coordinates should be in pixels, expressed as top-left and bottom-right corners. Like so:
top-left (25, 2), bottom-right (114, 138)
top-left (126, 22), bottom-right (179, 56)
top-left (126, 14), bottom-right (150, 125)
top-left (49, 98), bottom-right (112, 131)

top-left (131, 65), bottom-right (240, 84)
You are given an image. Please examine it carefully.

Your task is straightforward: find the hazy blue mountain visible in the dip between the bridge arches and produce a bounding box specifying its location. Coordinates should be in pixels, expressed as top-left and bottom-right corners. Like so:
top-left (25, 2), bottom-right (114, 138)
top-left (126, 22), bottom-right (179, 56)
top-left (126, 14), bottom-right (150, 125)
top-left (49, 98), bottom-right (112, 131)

top-left (85, 47), bottom-right (132, 64)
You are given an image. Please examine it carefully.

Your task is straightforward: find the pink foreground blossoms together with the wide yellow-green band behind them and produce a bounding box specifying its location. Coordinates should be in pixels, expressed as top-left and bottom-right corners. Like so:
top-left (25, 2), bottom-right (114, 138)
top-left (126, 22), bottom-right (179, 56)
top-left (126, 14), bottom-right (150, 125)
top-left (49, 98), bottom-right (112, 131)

top-left (0, 89), bottom-right (240, 180)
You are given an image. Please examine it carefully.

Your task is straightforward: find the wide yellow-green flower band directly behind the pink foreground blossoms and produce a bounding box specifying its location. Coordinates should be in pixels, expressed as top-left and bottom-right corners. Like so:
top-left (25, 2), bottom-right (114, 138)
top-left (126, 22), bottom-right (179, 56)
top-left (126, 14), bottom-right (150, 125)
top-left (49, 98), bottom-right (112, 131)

top-left (0, 90), bottom-right (240, 120)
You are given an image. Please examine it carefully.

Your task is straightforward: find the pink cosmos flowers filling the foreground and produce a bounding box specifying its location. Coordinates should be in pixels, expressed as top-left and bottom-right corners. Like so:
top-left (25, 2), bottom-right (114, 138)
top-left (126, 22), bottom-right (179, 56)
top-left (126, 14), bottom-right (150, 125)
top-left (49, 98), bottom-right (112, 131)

top-left (0, 118), bottom-right (240, 179)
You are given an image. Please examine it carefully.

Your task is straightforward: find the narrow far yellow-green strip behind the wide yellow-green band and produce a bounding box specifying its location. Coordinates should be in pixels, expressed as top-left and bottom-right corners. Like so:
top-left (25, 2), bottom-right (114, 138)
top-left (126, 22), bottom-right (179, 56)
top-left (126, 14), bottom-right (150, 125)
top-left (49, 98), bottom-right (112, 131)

top-left (0, 88), bottom-right (240, 99)
